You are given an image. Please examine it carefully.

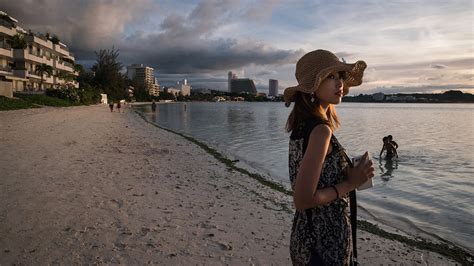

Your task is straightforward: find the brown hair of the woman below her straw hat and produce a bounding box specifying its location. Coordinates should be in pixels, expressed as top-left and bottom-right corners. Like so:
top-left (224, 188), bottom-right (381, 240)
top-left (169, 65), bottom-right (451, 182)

top-left (286, 91), bottom-right (340, 132)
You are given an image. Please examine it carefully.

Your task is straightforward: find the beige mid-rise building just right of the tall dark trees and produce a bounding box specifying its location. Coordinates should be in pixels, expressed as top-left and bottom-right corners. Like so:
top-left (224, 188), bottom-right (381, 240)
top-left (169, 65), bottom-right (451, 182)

top-left (127, 64), bottom-right (156, 96)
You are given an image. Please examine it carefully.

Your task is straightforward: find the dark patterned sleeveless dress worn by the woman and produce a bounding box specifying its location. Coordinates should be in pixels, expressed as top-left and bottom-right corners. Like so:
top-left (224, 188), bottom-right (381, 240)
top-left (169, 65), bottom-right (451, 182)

top-left (289, 118), bottom-right (351, 265)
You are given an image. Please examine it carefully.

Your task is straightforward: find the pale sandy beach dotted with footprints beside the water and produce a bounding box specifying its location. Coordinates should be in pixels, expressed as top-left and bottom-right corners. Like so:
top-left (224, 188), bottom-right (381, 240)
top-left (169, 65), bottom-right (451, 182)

top-left (0, 106), bottom-right (460, 265)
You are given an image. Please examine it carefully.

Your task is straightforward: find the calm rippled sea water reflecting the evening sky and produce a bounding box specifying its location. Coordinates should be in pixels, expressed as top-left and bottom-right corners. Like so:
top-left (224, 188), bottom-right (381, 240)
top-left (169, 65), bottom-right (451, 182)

top-left (135, 102), bottom-right (474, 252)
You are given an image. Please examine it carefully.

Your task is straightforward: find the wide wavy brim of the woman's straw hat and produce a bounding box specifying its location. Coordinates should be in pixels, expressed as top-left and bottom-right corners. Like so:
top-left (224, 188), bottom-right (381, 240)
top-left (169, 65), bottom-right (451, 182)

top-left (283, 61), bottom-right (367, 107)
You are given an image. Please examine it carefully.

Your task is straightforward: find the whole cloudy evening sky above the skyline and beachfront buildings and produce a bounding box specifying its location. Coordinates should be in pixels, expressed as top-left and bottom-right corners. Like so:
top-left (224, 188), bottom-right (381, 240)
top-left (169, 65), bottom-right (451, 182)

top-left (0, 0), bottom-right (474, 95)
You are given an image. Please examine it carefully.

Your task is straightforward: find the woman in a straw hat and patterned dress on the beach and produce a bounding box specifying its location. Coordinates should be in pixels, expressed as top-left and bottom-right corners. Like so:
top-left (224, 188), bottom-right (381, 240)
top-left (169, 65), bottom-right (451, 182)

top-left (284, 50), bottom-right (374, 265)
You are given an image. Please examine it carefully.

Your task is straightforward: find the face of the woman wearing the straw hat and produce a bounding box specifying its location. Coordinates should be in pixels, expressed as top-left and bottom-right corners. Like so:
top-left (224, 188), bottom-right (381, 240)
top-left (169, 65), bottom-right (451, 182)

top-left (316, 72), bottom-right (344, 105)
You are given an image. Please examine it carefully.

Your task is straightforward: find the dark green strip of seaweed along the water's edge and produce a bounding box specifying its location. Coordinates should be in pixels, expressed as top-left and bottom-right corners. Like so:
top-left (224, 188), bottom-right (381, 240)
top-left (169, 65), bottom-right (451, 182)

top-left (134, 104), bottom-right (474, 264)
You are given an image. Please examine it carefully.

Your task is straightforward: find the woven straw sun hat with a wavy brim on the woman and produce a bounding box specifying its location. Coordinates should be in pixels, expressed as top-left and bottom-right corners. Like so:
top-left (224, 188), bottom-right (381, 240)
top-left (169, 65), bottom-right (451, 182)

top-left (283, 50), bottom-right (367, 107)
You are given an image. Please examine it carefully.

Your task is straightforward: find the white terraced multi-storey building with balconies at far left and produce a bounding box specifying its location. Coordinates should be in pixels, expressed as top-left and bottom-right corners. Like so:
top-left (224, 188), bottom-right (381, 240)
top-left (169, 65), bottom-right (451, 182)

top-left (0, 11), bottom-right (79, 97)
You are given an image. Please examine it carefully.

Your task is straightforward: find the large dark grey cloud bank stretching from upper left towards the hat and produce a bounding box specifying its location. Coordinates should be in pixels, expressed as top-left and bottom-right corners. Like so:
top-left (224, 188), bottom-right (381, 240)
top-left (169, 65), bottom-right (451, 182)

top-left (2, 0), bottom-right (303, 73)
